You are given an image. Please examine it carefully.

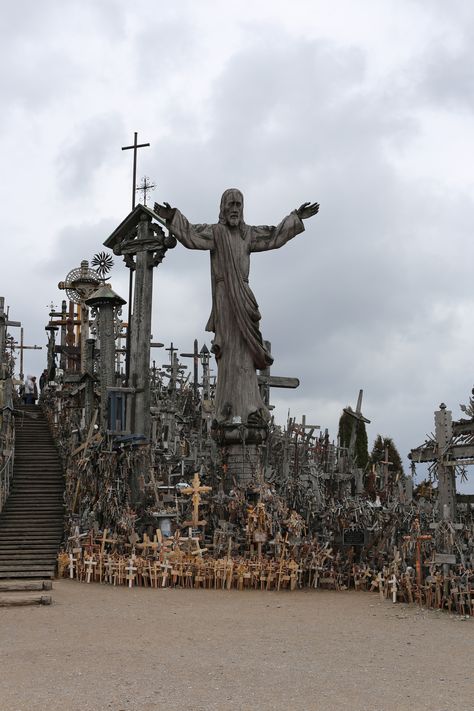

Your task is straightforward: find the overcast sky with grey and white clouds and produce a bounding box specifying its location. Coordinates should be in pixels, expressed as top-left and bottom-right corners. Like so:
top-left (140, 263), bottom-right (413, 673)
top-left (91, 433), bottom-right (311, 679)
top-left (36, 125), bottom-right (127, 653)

top-left (0, 0), bottom-right (474, 488)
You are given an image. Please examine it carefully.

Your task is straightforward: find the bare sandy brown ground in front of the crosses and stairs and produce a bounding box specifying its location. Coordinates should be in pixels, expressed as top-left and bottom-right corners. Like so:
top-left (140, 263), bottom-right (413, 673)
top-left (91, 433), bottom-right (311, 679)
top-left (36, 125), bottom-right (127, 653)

top-left (0, 581), bottom-right (474, 711)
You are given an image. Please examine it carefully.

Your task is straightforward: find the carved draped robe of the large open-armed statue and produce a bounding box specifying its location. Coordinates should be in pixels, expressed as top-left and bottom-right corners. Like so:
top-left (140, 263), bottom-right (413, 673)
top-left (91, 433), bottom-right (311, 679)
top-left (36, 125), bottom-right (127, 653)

top-left (167, 210), bottom-right (304, 423)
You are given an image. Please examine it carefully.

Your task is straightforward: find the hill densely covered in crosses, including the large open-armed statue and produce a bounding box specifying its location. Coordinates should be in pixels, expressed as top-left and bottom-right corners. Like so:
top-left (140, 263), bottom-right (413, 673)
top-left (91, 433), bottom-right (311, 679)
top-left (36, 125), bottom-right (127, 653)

top-left (0, 189), bottom-right (474, 614)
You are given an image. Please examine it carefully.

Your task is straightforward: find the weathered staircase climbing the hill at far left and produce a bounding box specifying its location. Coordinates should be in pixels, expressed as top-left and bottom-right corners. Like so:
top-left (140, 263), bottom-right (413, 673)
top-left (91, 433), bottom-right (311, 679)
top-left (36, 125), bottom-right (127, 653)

top-left (0, 405), bottom-right (64, 604)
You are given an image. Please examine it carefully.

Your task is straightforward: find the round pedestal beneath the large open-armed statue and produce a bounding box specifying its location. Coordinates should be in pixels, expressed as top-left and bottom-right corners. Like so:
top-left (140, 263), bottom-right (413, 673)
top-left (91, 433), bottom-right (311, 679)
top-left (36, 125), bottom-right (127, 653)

top-left (213, 424), bottom-right (268, 491)
